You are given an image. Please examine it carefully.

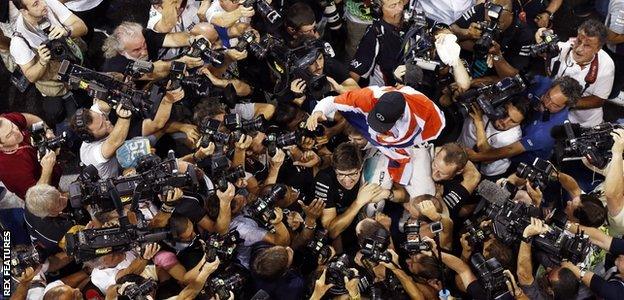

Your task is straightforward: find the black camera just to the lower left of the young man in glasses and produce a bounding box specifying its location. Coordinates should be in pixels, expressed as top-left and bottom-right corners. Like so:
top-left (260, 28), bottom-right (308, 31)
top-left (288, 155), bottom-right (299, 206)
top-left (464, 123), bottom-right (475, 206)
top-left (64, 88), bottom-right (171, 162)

top-left (245, 184), bottom-right (288, 232)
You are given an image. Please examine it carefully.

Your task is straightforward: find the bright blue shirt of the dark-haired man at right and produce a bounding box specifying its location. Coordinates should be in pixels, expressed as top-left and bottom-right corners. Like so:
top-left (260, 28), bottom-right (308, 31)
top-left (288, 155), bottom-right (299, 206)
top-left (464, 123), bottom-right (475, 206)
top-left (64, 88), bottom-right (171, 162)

top-left (513, 76), bottom-right (568, 164)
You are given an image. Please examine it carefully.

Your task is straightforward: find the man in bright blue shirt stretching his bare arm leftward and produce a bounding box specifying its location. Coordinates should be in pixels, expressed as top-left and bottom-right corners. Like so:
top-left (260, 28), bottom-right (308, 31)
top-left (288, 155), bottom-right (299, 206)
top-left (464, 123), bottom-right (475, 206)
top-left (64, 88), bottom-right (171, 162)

top-left (466, 76), bottom-right (581, 168)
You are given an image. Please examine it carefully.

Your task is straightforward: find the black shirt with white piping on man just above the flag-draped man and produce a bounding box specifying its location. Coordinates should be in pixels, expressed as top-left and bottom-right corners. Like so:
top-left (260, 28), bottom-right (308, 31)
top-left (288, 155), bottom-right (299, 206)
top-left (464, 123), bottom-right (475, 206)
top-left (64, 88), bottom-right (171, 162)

top-left (350, 20), bottom-right (403, 85)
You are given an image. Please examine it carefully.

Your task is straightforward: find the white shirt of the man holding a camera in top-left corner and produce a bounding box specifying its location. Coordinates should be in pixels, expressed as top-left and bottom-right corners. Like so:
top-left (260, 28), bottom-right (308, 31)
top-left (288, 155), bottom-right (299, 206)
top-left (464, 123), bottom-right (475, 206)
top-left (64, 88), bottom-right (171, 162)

top-left (11, 0), bottom-right (72, 65)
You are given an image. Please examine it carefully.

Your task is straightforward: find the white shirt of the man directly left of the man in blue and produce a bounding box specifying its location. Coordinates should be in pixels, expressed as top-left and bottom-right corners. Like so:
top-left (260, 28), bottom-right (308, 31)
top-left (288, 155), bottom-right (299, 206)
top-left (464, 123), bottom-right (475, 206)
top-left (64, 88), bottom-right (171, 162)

top-left (459, 116), bottom-right (522, 176)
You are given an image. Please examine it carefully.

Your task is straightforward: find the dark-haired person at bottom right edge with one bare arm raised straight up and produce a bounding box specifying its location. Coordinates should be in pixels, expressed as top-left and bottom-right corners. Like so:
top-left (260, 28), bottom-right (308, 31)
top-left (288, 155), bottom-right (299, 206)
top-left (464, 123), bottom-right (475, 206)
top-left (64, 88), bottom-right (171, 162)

top-left (517, 218), bottom-right (584, 299)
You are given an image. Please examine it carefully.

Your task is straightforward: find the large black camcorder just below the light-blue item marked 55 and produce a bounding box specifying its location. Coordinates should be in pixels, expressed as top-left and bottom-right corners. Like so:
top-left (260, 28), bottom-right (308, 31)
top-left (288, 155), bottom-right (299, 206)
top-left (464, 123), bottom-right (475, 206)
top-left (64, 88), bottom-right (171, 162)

top-left (69, 151), bottom-right (199, 212)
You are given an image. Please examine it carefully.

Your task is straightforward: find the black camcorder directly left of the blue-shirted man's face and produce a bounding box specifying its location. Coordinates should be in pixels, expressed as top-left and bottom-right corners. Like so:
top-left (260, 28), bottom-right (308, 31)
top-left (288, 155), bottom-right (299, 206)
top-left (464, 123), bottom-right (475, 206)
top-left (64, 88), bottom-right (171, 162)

top-left (456, 74), bottom-right (527, 120)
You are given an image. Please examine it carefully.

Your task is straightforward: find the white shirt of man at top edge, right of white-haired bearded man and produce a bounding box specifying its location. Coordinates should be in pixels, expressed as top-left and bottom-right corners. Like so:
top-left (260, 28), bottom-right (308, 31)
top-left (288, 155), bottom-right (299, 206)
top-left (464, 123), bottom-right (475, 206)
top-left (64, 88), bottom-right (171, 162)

top-left (147, 1), bottom-right (199, 59)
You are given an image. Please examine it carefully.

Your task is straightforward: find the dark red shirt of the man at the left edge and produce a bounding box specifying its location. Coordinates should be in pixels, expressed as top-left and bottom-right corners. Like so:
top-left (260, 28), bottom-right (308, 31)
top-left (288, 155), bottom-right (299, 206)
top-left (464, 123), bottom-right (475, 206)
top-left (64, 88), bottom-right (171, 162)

top-left (0, 113), bottom-right (61, 199)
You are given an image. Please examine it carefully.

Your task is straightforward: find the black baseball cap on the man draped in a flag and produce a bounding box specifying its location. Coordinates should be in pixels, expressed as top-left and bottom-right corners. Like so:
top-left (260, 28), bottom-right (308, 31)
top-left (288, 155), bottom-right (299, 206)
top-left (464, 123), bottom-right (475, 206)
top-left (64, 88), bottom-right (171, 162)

top-left (366, 92), bottom-right (405, 133)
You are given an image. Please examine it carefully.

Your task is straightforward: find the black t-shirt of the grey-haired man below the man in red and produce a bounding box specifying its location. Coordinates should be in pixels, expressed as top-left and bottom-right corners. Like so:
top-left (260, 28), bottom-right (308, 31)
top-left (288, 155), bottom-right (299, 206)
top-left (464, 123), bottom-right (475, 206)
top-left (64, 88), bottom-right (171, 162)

top-left (24, 209), bottom-right (74, 261)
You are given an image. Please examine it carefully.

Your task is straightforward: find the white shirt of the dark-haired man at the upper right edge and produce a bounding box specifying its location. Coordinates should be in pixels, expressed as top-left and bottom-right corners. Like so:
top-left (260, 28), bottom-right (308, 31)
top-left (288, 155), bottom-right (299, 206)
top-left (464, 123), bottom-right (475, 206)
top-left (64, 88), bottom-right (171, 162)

top-left (550, 40), bottom-right (615, 127)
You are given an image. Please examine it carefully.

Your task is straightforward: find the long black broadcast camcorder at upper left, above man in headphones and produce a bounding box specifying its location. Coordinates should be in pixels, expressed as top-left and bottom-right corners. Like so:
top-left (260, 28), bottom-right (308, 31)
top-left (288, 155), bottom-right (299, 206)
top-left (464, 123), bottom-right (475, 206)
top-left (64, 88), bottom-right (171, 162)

top-left (58, 60), bottom-right (164, 119)
